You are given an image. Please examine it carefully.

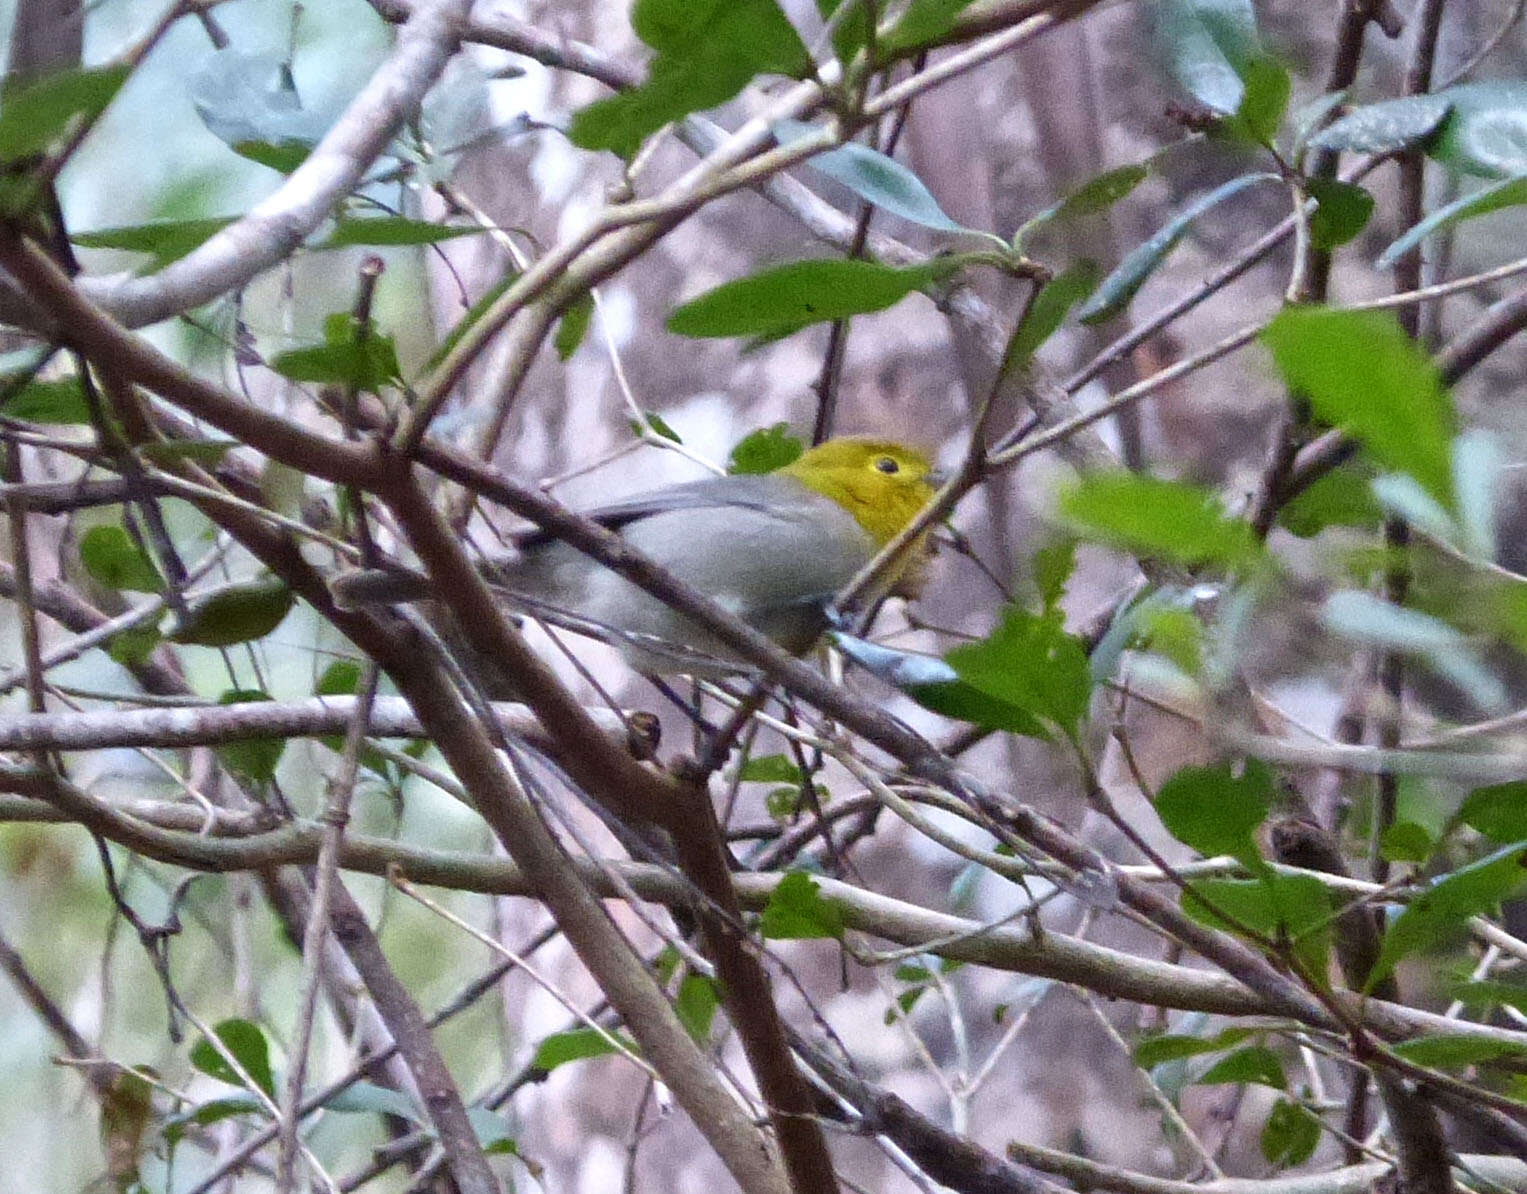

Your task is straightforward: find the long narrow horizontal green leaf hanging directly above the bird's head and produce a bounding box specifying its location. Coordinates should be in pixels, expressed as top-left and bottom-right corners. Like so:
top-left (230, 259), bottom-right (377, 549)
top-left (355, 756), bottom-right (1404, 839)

top-left (667, 258), bottom-right (935, 337)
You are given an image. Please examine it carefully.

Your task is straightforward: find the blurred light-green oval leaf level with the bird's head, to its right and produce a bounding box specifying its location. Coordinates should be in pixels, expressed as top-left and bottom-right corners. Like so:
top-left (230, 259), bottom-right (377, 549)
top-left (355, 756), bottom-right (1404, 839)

top-left (1060, 472), bottom-right (1261, 570)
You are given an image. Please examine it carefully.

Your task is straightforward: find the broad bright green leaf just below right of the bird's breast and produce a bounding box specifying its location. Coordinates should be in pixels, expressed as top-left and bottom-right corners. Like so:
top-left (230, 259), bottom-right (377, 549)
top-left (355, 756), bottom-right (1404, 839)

top-left (945, 605), bottom-right (1092, 737)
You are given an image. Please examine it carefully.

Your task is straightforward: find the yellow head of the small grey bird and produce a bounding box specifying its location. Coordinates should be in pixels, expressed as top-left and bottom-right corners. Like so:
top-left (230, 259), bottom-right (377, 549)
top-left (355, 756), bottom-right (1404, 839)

top-left (780, 435), bottom-right (939, 547)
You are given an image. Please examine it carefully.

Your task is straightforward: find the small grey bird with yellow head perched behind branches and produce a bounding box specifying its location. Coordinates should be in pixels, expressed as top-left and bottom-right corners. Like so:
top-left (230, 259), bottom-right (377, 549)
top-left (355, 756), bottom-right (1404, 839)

top-left (330, 435), bottom-right (942, 678)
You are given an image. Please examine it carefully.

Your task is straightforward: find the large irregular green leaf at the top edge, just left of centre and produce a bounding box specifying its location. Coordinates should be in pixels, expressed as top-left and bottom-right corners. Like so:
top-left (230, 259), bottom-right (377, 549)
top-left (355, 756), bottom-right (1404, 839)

top-left (568, 0), bottom-right (811, 157)
